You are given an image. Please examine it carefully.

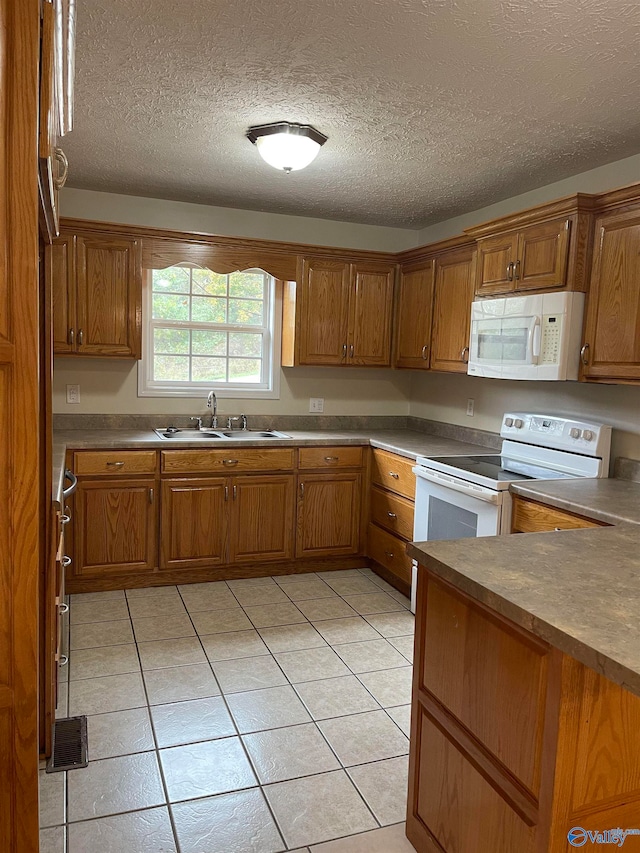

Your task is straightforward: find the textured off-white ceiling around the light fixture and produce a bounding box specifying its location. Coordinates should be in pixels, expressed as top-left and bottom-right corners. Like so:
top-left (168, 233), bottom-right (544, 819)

top-left (64, 0), bottom-right (640, 228)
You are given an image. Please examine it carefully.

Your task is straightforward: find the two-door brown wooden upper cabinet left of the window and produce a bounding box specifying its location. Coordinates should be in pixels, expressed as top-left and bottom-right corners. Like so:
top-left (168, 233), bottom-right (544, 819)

top-left (47, 232), bottom-right (142, 358)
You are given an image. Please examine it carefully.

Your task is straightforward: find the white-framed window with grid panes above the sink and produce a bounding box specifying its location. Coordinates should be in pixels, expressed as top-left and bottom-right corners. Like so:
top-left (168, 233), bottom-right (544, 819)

top-left (138, 264), bottom-right (280, 397)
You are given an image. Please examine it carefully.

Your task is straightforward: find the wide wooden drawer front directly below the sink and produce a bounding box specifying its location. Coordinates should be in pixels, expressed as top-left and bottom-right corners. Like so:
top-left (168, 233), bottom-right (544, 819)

top-left (162, 447), bottom-right (295, 474)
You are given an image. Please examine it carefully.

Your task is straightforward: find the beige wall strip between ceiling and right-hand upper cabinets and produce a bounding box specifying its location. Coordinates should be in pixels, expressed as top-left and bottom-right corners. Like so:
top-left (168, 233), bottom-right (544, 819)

top-left (416, 154), bottom-right (640, 241)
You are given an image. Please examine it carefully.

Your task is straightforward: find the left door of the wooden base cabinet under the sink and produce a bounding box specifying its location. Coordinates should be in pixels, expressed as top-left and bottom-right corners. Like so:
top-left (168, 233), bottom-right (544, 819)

top-left (160, 477), bottom-right (229, 569)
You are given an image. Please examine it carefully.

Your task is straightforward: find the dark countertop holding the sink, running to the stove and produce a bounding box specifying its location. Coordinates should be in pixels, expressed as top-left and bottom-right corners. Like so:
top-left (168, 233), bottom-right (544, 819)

top-left (53, 429), bottom-right (497, 500)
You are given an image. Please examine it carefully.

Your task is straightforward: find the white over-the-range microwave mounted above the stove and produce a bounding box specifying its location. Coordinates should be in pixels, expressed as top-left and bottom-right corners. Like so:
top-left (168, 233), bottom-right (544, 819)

top-left (467, 291), bottom-right (584, 381)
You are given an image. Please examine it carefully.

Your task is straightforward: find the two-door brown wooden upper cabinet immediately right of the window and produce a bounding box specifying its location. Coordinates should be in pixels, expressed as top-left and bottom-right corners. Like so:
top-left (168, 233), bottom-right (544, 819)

top-left (282, 258), bottom-right (396, 367)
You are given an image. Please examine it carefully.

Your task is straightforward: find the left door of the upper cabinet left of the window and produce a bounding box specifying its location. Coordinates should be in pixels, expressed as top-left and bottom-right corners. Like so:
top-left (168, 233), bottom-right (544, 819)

top-left (46, 234), bottom-right (76, 355)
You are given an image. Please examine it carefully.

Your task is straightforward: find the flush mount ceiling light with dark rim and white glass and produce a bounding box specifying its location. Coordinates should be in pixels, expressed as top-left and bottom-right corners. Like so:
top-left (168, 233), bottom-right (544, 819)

top-left (247, 121), bottom-right (328, 173)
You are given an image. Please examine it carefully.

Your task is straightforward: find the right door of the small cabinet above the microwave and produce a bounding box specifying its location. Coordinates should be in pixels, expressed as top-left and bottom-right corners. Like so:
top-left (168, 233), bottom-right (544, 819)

top-left (513, 219), bottom-right (571, 290)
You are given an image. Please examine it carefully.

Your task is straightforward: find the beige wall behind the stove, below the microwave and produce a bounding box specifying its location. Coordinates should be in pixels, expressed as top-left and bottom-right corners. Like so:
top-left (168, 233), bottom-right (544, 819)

top-left (410, 373), bottom-right (640, 459)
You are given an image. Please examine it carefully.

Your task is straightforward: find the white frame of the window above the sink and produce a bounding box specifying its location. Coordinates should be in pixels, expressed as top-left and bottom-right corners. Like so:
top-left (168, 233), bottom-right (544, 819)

top-left (138, 262), bottom-right (282, 400)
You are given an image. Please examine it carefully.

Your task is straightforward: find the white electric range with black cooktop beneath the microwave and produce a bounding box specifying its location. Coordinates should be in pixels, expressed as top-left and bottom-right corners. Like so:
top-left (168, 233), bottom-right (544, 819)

top-left (411, 412), bottom-right (611, 612)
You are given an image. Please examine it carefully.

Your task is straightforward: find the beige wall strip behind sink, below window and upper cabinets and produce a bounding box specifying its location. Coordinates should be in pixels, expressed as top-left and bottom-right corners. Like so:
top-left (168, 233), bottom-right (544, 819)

top-left (53, 358), bottom-right (411, 415)
